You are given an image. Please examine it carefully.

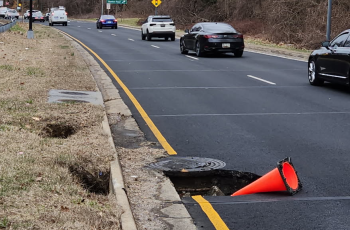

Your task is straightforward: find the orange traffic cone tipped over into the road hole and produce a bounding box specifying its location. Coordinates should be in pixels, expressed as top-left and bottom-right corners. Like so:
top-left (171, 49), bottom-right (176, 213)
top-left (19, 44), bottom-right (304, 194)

top-left (231, 157), bottom-right (302, 196)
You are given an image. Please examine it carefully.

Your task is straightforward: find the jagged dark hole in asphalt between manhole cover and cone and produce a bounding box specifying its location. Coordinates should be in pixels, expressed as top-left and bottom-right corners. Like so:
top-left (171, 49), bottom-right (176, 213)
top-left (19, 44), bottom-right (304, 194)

top-left (164, 169), bottom-right (260, 198)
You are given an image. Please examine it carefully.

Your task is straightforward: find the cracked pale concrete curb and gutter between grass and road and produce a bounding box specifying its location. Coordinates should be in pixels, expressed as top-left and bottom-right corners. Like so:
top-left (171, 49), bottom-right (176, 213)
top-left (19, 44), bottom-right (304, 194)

top-left (67, 28), bottom-right (197, 230)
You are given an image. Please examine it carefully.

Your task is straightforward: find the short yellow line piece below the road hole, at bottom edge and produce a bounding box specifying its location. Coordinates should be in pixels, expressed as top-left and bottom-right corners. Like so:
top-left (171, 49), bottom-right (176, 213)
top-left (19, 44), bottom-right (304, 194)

top-left (192, 196), bottom-right (229, 230)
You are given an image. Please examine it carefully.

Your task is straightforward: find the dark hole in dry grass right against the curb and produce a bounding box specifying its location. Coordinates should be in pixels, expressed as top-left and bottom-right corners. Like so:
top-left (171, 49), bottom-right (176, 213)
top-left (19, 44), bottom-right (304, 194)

top-left (69, 165), bottom-right (110, 195)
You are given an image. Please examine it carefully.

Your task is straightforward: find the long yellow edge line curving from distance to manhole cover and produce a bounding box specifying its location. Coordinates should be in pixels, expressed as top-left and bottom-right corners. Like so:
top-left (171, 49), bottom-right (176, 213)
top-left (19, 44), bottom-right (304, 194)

top-left (60, 31), bottom-right (177, 155)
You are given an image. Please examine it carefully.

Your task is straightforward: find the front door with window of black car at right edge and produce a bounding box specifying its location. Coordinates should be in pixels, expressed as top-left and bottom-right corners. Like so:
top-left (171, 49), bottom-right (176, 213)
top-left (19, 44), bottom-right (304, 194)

top-left (317, 32), bottom-right (349, 82)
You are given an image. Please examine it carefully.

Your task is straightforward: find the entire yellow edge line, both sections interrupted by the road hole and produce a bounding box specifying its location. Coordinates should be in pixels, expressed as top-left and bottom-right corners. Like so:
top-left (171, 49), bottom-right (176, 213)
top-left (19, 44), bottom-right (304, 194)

top-left (61, 31), bottom-right (229, 230)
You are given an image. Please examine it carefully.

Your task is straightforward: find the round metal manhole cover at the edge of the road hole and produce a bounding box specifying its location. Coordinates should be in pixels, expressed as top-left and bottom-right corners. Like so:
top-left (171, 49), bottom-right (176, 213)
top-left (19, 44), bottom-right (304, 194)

top-left (149, 157), bottom-right (226, 172)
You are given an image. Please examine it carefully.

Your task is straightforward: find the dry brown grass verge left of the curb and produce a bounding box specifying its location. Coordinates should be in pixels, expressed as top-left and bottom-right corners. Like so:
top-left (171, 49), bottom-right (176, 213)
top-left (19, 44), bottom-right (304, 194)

top-left (0, 24), bottom-right (120, 229)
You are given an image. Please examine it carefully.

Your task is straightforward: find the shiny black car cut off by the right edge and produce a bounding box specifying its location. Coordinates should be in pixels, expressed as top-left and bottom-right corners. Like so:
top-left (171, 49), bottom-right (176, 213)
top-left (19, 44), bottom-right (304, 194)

top-left (308, 29), bottom-right (350, 85)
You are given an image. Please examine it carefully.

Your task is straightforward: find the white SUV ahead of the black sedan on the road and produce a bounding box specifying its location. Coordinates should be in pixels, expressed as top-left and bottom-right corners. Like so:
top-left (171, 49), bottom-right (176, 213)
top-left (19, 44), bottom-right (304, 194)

top-left (141, 15), bottom-right (176, 41)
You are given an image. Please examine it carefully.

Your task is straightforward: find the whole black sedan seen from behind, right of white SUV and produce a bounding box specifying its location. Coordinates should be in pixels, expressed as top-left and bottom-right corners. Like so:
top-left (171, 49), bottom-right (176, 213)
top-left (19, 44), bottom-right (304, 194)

top-left (180, 22), bottom-right (244, 57)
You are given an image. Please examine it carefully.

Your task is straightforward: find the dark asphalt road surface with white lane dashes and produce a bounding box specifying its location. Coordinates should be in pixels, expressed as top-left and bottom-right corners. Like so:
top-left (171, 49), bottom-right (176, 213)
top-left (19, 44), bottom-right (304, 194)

top-left (55, 21), bottom-right (350, 229)
